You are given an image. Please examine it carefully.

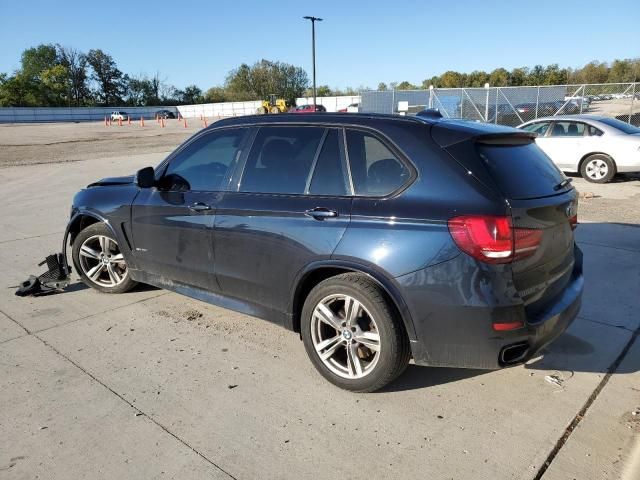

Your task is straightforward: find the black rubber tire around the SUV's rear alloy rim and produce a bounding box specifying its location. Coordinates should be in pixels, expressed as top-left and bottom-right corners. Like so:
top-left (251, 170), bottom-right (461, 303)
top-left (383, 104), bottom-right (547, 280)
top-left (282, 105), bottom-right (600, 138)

top-left (300, 273), bottom-right (411, 392)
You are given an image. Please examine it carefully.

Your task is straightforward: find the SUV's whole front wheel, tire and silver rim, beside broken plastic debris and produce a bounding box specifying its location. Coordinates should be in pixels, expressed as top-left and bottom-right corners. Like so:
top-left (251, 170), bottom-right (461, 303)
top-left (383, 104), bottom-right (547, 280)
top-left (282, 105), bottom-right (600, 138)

top-left (71, 223), bottom-right (137, 293)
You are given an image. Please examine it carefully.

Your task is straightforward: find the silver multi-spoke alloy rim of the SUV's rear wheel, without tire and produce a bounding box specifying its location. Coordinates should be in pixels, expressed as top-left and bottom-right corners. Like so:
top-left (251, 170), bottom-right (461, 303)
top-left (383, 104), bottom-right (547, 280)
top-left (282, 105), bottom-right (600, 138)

top-left (311, 294), bottom-right (381, 379)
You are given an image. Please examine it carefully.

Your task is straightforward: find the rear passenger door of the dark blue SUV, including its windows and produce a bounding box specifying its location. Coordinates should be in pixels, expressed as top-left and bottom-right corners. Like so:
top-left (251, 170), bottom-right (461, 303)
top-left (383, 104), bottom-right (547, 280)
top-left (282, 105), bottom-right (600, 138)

top-left (214, 126), bottom-right (351, 313)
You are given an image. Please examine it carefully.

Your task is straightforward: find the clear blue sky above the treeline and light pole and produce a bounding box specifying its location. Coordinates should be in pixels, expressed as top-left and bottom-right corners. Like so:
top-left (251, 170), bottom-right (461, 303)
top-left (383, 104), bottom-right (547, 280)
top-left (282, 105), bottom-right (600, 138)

top-left (0, 0), bottom-right (640, 89)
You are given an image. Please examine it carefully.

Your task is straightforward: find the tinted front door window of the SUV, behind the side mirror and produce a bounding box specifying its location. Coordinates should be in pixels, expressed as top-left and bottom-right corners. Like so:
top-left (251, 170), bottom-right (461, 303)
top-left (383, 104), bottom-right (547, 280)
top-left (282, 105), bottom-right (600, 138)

top-left (159, 128), bottom-right (247, 192)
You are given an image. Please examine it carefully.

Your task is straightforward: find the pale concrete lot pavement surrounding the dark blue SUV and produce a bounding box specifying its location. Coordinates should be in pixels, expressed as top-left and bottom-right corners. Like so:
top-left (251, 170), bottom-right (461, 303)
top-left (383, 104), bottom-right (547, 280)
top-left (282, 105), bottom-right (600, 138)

top-left (0, 124), bottom-right (640, 480)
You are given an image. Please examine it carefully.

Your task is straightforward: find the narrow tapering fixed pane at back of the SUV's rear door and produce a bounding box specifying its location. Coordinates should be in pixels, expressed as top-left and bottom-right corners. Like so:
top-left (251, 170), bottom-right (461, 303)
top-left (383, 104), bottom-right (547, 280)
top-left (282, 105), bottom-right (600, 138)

top-left (309, 129), bottom-right (348, 196)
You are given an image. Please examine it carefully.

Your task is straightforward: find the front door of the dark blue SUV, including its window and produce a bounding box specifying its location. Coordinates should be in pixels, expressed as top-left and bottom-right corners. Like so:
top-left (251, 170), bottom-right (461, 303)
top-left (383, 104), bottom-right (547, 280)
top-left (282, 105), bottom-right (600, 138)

top-left (131, 128), bottom-right (248, 290)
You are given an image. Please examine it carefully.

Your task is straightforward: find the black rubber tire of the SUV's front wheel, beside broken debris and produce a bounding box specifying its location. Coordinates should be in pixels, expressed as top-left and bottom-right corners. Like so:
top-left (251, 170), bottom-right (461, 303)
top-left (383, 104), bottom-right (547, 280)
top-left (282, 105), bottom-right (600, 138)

top-left (71, 222), bottom-right (138, 293)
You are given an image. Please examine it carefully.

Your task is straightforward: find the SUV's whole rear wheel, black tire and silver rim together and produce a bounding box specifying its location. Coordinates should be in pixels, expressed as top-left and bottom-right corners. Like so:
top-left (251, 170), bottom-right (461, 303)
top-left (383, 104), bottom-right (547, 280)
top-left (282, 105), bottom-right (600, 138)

top-left (300, 273), bottom-right (410, 392)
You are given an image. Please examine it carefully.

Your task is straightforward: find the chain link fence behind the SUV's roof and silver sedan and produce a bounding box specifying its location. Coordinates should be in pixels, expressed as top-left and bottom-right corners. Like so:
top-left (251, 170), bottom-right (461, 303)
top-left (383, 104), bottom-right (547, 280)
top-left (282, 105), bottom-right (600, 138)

top-left (360, 83), bottom-right (640, 126)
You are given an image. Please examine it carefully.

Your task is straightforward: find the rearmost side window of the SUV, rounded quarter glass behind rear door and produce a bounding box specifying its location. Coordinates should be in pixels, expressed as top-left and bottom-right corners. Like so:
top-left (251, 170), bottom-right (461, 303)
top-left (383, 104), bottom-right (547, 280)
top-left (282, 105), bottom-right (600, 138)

top-left (347, 130), bottom-right (410, 196)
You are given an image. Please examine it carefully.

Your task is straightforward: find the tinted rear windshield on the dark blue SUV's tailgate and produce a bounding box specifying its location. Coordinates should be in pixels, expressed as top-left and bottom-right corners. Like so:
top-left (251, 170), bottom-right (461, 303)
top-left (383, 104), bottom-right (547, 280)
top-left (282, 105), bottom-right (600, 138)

top-left (478, 143), bottom-right (571, 200)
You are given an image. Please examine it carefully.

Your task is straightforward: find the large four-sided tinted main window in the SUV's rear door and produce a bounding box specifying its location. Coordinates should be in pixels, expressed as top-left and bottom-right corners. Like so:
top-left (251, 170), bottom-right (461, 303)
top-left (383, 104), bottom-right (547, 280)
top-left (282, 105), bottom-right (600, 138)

top-left (240, 127), bottom-right (325, 194)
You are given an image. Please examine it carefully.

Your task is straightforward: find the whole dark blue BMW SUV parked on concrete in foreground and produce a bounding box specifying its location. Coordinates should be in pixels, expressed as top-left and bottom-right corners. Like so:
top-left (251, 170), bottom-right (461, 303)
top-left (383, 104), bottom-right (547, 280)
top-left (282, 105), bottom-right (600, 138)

top-left (65, 113), bottom-right (583, 392)
